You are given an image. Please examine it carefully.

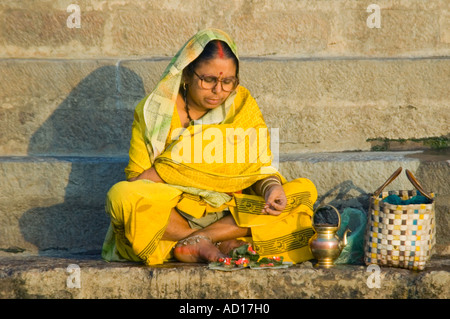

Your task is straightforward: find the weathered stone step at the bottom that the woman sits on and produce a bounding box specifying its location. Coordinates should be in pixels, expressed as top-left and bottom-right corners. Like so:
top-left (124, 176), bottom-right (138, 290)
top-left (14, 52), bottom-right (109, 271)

top-left (0, 256), bottom-right (450, 300)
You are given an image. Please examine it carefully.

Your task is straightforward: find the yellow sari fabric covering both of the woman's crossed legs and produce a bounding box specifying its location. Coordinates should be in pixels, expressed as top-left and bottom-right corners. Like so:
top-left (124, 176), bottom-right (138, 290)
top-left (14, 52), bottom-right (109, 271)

top-left (102, 178), bottom-right (317, 265)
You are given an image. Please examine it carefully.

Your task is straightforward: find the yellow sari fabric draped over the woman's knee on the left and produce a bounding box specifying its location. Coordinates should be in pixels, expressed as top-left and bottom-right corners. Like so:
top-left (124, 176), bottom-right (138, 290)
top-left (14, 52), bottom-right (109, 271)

top-left (102, 180), bottom-right (181, 264)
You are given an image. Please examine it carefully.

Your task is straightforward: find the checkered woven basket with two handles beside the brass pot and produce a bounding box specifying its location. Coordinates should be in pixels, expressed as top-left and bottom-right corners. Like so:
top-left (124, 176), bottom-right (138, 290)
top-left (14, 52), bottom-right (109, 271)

top-left (364, 167), bottom-right (436, 270)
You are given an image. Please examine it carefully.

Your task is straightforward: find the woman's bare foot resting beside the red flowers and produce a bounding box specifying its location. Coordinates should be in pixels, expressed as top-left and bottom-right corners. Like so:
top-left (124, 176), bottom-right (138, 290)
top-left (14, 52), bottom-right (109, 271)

top-left (173, 235), bottom-right (227, 263)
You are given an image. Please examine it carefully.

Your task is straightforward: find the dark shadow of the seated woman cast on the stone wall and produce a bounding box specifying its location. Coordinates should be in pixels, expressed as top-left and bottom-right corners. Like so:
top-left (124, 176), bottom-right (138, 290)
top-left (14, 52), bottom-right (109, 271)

top-left (19, 66), bottom-right (145, 254)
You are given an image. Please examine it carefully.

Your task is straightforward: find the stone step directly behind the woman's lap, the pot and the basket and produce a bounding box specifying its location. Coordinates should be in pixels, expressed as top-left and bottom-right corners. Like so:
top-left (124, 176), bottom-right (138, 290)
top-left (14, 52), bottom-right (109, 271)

top-left (0, 150), bottom-right (450, 254)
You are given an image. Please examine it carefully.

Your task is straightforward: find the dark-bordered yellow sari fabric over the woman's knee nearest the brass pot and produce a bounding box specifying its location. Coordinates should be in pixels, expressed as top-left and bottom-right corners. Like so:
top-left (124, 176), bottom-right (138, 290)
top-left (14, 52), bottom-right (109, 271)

top-left (230, 178), bottom-right (317, 263)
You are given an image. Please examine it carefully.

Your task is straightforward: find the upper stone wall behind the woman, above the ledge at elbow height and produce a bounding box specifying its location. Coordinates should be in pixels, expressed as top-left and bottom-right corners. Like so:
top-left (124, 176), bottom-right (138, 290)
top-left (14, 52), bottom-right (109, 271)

top-left (0, 0), bottom-right (450, 155)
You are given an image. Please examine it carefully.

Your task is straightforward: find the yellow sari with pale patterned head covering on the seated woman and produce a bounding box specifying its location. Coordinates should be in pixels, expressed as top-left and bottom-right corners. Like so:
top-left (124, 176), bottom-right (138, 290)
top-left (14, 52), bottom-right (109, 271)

top-left (102, 29), bottom-right (317, 265)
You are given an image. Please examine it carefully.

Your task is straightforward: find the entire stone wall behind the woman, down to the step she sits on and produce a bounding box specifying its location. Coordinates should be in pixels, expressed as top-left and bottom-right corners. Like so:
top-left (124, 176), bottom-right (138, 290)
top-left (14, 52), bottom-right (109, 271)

top-left (0, 0), bottom-right (450, 253)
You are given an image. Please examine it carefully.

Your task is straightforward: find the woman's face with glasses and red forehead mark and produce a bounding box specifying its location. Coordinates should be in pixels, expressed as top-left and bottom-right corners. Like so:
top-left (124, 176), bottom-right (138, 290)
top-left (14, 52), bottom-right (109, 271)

top-left (186, 57), bottom-right (236, 112)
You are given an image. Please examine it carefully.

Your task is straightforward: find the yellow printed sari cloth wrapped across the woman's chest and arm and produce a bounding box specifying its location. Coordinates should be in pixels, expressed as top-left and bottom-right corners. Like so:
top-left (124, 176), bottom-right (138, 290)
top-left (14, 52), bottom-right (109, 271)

top-left (154, 86), bottom-right (277, 192)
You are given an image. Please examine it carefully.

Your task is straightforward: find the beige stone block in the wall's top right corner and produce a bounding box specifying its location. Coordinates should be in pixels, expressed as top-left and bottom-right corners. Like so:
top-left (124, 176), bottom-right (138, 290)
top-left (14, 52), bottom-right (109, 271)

top-left (329, 1), bottom-right (450, 57)
